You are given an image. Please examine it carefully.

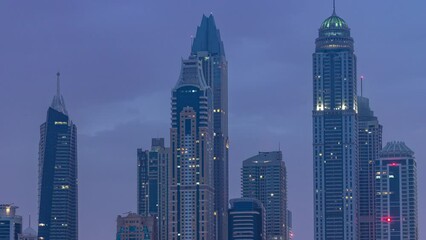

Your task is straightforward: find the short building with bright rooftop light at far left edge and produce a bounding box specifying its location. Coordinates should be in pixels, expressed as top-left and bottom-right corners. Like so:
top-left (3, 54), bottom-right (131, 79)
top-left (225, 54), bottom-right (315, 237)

top-left (0, 204), bottom-right (22, 240)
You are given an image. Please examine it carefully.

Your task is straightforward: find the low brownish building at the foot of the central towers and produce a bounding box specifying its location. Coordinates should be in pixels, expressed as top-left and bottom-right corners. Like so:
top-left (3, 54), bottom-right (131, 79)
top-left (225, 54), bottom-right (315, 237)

top-left (116, 213), bottom-right (158, 240)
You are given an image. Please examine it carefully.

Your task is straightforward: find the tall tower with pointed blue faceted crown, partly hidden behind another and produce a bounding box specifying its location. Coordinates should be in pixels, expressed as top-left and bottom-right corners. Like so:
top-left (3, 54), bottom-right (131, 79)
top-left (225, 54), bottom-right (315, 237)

top-left (191, 15), bottom-right (229, 240)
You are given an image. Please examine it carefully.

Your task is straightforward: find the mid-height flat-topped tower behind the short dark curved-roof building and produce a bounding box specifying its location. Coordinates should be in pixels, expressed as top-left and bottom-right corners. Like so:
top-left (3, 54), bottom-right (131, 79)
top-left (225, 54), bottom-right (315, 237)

top-left (241, 151), bottom-right (289, 240)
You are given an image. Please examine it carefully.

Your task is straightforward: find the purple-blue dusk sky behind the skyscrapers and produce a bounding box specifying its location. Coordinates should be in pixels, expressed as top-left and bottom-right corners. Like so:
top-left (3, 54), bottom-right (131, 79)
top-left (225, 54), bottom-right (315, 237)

top-left (0, 0), bottom-right (426, 240)
